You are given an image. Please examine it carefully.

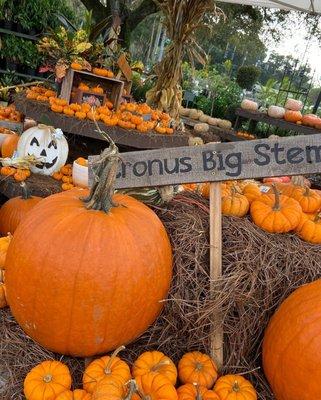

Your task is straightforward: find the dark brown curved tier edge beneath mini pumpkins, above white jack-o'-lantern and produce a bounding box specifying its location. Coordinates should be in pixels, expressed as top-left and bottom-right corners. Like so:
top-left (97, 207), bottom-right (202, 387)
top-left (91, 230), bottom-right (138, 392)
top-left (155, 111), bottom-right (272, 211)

top-left (15, 94), bottom-right (188, 150)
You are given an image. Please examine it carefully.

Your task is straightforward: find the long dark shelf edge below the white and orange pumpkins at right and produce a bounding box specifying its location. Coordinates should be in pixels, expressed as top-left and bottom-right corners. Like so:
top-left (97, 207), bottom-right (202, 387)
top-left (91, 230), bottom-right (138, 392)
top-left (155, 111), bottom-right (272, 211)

top-left (235, 108), bottom-right (321, 135)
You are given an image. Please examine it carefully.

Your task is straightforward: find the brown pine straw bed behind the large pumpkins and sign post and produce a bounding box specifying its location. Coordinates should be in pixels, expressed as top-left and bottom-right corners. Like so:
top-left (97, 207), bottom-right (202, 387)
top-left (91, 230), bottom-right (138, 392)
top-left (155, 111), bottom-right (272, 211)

top-left (0, 193), bottom-right (321, 400)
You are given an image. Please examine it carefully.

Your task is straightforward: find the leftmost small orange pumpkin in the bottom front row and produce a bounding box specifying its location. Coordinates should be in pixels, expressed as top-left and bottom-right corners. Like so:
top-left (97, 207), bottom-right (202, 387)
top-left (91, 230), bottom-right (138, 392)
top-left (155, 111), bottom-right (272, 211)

top-left (24, 360), bottom-right (71, 400)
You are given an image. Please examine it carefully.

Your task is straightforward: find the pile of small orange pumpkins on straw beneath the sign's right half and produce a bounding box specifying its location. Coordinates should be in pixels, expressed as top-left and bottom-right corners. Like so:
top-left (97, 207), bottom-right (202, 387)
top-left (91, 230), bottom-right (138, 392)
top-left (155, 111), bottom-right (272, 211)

top-left (184, 180), bottom-right (321, 244)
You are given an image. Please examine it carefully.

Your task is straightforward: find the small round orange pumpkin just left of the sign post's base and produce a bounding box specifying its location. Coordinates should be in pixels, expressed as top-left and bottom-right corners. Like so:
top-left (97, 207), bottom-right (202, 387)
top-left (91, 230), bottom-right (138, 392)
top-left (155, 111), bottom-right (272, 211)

top-left (178, 351), bottom-right (217, 389)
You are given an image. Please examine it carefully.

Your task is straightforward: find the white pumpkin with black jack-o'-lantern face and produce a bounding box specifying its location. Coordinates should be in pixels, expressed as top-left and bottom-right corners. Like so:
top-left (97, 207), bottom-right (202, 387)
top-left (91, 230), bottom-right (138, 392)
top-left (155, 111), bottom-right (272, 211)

top-left (17, 124), bottom-right (68, 175)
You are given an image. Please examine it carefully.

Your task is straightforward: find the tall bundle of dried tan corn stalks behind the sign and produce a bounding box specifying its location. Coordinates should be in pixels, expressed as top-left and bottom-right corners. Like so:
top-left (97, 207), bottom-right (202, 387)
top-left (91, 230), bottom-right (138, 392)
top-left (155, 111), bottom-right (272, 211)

top-left (146, 0), bottom-right (224, 123)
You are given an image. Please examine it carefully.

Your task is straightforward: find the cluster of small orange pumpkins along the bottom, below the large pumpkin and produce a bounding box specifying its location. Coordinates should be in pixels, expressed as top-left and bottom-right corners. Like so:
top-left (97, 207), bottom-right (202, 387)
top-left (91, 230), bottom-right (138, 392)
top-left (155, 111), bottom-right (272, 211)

top-left (24, 347), bottom-right (257, 400)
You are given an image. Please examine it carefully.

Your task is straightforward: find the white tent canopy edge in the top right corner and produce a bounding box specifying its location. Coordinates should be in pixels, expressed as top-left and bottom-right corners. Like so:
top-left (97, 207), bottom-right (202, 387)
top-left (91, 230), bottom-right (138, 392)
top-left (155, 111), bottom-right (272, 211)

top-left (220, 0), bottom-right (321, 14)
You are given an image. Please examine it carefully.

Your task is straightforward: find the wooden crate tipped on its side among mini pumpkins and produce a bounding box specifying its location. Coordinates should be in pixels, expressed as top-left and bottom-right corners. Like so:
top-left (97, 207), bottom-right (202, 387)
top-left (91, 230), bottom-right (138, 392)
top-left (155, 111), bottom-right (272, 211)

top-left (60, 69), bottom-right (124, 110)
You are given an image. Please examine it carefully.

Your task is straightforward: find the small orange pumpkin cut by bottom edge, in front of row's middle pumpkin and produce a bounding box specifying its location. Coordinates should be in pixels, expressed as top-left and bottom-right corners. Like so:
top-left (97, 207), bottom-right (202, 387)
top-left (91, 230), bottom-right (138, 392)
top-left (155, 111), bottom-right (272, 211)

top-left (136, 372), bottom-right (178, 400)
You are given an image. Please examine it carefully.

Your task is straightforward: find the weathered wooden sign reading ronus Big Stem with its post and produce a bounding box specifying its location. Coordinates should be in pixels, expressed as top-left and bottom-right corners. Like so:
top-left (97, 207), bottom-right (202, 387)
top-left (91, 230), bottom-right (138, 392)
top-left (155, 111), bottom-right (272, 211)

top-left (89, 134), bottom-right (321, 365)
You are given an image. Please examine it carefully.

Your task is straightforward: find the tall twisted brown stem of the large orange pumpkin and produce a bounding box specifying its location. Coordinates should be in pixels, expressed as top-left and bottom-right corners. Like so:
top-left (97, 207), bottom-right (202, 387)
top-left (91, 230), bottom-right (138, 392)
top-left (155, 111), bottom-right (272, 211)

top-left (82, 115), bottom-right (120, 213)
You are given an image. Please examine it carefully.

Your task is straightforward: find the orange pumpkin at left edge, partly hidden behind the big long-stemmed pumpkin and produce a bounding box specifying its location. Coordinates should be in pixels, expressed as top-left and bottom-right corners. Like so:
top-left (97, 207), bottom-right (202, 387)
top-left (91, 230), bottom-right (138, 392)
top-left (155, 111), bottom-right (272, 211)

top-left (0, 184), bottom-right (42, 234)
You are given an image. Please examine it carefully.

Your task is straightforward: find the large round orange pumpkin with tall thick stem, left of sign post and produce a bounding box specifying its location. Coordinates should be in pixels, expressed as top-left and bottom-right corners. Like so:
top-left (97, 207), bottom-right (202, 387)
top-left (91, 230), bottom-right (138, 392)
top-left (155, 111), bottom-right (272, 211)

top-left (5, 149), bottom-right (172, 356)
